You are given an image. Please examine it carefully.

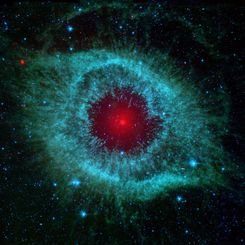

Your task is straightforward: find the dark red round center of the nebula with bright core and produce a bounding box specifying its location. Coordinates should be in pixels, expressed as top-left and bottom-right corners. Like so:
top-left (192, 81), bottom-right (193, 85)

top-left (88, 87), bottom-right (161, 153)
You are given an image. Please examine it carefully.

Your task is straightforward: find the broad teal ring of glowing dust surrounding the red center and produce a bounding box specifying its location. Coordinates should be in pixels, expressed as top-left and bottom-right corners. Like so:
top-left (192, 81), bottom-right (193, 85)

top-left (20, 47), bottom-right (228, 200)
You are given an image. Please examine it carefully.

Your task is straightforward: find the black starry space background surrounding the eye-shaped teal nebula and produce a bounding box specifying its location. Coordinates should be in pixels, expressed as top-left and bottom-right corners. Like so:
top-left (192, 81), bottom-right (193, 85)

top-left (0, 1), bottom-right (245, 244)
